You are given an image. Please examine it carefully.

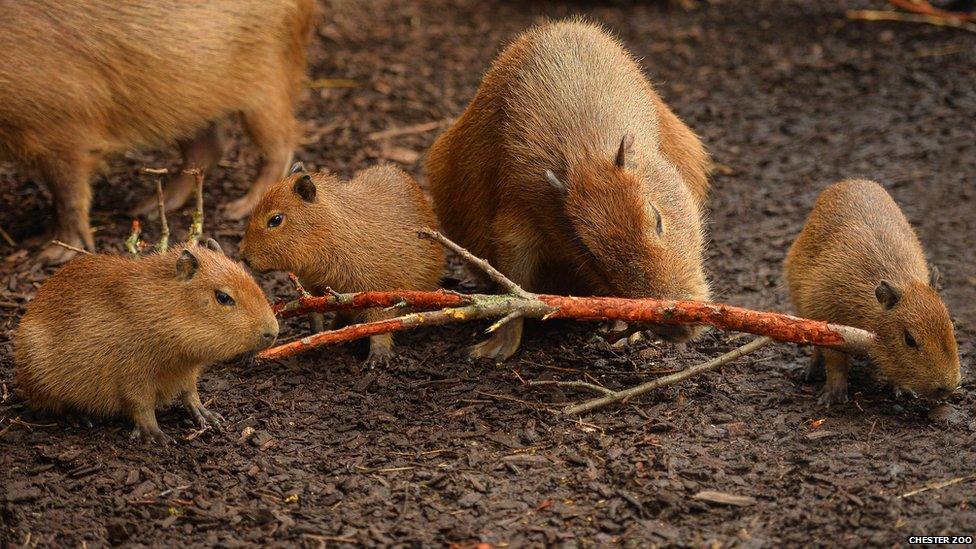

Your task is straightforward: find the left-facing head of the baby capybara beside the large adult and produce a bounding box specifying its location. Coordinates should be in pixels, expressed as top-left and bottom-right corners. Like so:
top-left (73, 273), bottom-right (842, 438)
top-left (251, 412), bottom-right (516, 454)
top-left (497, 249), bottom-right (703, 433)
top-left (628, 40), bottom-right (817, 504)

top-left (241, 163), bottom-right (341, 273)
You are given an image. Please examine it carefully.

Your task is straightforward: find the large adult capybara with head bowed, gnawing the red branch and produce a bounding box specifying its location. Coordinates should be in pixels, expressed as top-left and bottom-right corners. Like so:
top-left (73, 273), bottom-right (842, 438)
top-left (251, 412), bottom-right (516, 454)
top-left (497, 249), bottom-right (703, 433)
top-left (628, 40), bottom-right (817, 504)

top-left (427, 20), bottom-right (709, 360)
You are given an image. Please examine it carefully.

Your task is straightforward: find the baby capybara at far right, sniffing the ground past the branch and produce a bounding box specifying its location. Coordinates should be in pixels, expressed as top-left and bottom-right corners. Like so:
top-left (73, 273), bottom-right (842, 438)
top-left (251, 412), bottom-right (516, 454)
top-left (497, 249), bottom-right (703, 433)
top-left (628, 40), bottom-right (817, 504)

top-left (786, 180), bottom-right (961, 405)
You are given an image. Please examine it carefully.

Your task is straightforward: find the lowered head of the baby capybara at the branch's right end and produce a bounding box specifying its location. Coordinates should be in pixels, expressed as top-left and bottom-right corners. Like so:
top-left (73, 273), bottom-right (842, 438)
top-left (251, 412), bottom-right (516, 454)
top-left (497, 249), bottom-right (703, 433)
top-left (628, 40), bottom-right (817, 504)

top-left (871, 280), bottom-right (962, 398)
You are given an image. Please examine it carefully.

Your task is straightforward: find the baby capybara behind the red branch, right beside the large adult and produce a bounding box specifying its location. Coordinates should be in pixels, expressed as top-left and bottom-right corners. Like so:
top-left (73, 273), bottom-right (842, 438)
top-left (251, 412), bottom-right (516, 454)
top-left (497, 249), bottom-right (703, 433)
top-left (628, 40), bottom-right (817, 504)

top-left (241, 163), bottom-right (444, 364)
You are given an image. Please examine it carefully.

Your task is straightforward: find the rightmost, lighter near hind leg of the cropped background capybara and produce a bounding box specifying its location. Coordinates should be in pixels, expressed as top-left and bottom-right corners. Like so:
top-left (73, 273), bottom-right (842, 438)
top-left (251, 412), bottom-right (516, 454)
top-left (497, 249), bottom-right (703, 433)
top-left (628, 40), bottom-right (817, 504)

top-left (225, 102), bottom-right (297, 219)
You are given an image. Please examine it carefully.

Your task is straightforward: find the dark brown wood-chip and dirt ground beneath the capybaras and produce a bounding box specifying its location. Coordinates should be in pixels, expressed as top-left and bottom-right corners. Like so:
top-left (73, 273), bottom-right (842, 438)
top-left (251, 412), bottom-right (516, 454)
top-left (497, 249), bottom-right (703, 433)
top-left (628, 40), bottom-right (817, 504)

top-left (0, 0), bottom-right (976, 546)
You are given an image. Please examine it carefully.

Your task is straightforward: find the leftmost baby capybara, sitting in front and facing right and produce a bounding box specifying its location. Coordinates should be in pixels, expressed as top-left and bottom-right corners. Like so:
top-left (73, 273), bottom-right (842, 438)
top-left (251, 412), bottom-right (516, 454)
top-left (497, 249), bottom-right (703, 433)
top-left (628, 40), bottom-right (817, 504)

top-left (14, 240), bottom-right (278, 443)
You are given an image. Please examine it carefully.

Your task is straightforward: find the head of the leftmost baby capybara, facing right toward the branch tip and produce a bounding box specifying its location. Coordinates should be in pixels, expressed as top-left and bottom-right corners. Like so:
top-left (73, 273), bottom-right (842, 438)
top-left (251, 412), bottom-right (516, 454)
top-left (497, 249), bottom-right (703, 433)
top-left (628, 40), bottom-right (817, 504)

top-left (170, 239), bottom-right (278, 360)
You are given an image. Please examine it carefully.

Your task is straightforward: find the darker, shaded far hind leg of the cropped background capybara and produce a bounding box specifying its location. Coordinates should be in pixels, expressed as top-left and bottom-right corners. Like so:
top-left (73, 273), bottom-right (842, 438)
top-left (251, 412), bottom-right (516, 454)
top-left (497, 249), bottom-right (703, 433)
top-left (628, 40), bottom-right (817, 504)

top-left (132, 122), bottom-right (224, 217)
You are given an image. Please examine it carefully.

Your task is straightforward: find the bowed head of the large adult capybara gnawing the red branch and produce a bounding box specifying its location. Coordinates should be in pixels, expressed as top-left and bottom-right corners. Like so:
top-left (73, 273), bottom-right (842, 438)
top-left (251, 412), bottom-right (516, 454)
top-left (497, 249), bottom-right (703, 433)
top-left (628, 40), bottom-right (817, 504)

top-left (546, 135), bottom-right (709, 340)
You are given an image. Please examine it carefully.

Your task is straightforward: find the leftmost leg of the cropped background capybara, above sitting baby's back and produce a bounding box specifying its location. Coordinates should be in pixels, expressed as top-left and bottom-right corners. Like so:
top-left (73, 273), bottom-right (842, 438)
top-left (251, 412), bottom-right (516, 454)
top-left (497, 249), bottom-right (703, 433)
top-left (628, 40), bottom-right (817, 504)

top-left (39, 153), bottom-right (96, 265)
